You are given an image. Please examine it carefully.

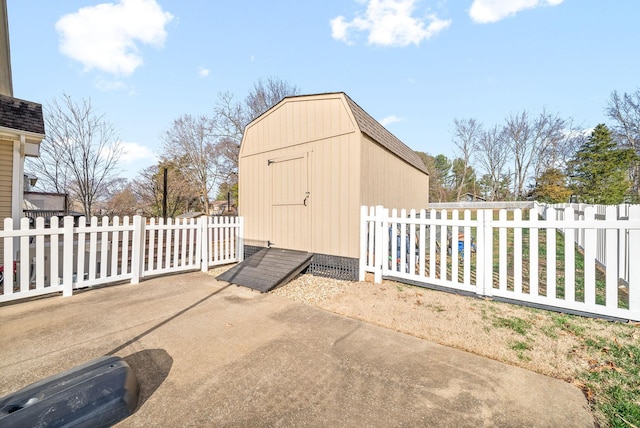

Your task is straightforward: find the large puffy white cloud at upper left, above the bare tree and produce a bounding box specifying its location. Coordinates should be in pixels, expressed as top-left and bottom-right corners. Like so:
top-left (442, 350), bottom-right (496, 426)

top-left (56, 0), bottom-right (173, 76)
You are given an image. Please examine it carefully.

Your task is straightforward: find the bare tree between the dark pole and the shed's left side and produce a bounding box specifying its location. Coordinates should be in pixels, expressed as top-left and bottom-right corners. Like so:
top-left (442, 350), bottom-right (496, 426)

top-left (162, 115), bottom-right (228, 213)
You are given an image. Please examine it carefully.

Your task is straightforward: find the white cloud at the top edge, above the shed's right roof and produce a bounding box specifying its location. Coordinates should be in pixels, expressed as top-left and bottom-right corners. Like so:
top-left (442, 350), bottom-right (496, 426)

top-left (330, 0), bottom-right (451, 46)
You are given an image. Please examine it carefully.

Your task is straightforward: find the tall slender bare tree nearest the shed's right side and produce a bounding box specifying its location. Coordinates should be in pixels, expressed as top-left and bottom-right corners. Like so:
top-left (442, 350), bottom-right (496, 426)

top-left (453, 119), bottom-right (482, 201)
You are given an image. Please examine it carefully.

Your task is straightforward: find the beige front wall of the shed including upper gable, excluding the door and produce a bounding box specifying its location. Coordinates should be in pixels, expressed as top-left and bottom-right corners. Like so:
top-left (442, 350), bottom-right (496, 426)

top-left (239, 94), bottom-right (360, 257)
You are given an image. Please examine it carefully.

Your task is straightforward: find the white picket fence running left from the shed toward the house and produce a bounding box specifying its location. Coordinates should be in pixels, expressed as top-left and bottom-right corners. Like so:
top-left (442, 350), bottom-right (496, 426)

top-left (0, 216), bottom-right (244, 302)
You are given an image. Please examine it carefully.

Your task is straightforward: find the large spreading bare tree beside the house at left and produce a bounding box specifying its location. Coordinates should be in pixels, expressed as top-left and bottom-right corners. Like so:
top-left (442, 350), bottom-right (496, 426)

top-left (30, 95), bottom-right (122, 216)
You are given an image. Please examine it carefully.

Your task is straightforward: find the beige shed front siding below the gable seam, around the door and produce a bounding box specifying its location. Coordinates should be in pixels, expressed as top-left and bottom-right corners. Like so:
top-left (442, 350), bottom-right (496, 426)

top-left (239, 133), bottom-right (360, 257)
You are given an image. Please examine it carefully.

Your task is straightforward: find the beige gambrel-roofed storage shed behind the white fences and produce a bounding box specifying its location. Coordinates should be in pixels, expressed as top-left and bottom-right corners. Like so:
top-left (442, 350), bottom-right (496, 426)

top-left (238, 92), bottom-right (429, 276)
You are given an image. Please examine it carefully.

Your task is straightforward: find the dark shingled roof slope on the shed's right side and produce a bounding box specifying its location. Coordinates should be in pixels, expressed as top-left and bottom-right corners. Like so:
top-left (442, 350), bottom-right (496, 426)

top-left (343, 92), bottom-right (428, 174)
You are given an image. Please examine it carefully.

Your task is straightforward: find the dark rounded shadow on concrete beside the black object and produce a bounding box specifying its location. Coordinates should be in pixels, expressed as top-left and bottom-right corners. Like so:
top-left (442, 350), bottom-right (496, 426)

top-left (123, 349), bottom-right (173, 411)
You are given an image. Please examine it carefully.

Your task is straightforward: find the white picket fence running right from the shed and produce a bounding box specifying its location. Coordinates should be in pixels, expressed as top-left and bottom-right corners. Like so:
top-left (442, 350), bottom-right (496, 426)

top-left (359, 206), bottom-right (640, 321)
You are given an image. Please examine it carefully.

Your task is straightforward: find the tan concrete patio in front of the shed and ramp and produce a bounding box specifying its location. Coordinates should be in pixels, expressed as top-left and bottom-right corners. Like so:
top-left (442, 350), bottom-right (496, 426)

top-left (0, 273), bottom-right (593, 427)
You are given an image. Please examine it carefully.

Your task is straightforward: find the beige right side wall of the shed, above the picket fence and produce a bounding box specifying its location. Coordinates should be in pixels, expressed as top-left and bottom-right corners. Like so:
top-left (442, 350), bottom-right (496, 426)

top-left (361, 135), bottom-right (429, 210)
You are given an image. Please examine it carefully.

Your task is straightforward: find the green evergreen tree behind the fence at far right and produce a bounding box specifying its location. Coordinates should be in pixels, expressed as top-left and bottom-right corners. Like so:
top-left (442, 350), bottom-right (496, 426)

top-left (569, 124), bottom-right (637, 205)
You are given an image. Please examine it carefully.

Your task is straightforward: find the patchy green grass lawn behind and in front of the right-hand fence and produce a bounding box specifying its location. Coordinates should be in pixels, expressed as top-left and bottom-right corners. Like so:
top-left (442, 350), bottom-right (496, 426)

top-left (412, 210), bottom-right (640, 427)
